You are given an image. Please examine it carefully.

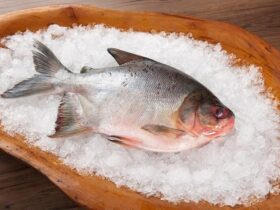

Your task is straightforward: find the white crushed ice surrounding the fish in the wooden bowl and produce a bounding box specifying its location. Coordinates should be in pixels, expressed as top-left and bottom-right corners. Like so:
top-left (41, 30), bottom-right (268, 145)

top-left (0, 25), bottom-right (280, 205)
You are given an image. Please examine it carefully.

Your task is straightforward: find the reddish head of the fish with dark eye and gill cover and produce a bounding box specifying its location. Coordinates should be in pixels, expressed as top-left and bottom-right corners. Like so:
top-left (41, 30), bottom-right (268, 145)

top-left (176, 91), bottom-right (235, 139)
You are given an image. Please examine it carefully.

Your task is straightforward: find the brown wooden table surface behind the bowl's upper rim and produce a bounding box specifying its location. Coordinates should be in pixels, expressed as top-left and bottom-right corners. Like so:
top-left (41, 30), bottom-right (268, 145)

top-left (0, 0), bottom-right (280, 49)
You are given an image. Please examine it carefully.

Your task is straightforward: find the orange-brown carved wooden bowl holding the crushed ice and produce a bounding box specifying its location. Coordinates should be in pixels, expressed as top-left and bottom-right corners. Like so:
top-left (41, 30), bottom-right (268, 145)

top-left (0, 5), bottom-right (280, 210)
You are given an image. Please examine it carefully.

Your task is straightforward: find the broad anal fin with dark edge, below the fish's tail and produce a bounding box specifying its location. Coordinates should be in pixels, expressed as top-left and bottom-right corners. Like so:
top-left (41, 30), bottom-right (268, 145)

top-left (49, 93), bottom-right (91, 138)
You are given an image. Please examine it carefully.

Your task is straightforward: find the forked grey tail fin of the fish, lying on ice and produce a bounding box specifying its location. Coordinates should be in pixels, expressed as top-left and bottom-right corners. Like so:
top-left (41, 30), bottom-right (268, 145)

top-left (1, 40), bottom-right (72, 98)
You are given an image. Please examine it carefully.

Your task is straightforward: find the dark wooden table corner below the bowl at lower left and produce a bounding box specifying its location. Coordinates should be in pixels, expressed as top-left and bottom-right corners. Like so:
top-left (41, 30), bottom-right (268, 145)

top-left (0, 152), bottom-right (81, 210)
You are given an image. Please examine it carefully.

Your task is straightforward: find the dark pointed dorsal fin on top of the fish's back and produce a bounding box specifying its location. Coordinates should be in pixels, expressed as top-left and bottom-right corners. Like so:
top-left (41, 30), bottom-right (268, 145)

top-left (107, 48), bottom-right (151, 65)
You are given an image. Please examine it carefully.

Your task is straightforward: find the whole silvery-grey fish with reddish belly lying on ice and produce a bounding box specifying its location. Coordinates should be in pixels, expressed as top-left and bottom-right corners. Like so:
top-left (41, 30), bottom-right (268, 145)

top-left (1, 40), bottom-right (235, 152)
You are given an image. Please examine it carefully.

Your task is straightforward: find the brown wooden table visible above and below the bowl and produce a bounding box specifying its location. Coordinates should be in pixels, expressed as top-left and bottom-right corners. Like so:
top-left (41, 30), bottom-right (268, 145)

top-left (0, 0), bottom-right (280, 210)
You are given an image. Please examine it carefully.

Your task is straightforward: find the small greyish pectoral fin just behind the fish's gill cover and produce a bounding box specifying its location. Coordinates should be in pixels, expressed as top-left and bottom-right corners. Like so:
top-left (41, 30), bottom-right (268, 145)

top-left (142, 124), bottom-right (185, 138)
